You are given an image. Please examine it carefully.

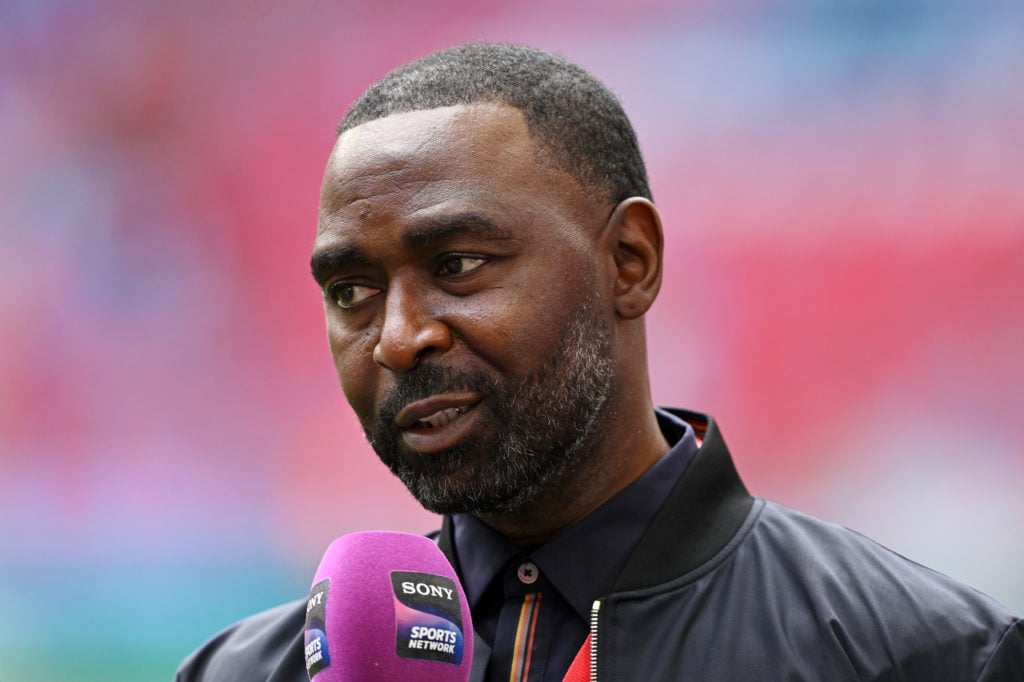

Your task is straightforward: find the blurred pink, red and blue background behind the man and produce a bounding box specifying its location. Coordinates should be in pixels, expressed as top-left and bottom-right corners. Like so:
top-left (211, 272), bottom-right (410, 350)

top-left (0, 0), bottom-right (1024, 682)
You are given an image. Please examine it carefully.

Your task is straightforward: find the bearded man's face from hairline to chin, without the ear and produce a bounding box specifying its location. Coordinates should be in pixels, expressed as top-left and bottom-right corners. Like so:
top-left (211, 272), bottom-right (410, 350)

top-left (312, 103), bottom-right (614, 513)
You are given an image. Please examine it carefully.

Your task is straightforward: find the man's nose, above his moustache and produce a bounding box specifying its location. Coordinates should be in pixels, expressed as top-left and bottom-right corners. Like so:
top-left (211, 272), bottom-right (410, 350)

top-left (374, 284), bottom-right (452, 374)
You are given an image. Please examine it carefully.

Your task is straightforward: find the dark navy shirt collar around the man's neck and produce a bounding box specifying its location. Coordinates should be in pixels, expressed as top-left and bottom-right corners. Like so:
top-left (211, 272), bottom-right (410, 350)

top-left (452, 410), bottom-right (697, 621)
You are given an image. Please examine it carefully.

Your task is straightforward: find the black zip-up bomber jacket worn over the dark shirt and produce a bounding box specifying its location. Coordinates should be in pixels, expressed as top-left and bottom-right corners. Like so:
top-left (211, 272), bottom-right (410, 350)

top-left (176, 410), bottom-right (1024, 682)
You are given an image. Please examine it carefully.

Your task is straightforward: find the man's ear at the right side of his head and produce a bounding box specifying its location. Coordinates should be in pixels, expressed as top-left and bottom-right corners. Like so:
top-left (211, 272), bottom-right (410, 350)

top-left (605, 197), bottom-right (665, 319)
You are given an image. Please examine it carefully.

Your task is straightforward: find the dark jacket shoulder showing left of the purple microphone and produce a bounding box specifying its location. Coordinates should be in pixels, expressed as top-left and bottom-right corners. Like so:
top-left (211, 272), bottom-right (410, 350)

top-left (175, 599), bottom-right (308, 682)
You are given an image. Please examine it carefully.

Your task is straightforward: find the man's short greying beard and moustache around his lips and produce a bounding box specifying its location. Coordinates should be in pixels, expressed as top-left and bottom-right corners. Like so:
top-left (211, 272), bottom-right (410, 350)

top-left (367, 306), bottom-right (613, 514)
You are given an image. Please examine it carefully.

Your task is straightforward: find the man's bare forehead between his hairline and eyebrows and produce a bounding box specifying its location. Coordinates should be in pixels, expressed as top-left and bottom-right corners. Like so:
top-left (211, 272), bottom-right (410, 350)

top-left (319, 102), bottom-right (592, 232)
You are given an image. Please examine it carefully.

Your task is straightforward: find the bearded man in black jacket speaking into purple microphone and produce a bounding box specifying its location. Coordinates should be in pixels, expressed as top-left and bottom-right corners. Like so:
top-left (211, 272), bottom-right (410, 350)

top-left (178, 45), bottom-right (1024, 681)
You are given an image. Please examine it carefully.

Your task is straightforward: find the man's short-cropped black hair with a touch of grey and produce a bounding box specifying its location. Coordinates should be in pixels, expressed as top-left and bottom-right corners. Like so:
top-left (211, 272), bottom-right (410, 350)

top-left (338, 43), bottom-right (651, 204)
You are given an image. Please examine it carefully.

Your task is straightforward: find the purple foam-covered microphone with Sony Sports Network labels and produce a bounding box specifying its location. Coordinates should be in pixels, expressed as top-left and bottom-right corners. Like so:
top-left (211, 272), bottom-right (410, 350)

top-left (305, 530), bottom-right (473, 682)
